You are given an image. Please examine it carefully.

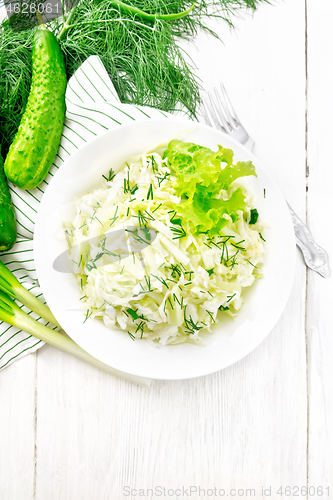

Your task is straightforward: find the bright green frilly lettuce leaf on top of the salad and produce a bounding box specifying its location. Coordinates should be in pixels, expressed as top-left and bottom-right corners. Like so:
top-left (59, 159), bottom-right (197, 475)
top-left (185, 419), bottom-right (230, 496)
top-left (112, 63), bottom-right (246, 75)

top-left (164, 140), bottom-right (256, 236)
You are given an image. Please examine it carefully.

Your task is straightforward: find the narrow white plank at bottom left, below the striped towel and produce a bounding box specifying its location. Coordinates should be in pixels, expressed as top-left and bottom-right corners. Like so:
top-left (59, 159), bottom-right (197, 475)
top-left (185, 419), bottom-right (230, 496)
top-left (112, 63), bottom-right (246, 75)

top-left (0, 354), bottom-right (36, 500)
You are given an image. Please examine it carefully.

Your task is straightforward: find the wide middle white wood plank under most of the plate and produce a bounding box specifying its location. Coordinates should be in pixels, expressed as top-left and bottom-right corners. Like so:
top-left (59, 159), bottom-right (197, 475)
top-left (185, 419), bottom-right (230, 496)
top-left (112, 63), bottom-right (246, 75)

top-left (32, 0), bottom-right (307, 500)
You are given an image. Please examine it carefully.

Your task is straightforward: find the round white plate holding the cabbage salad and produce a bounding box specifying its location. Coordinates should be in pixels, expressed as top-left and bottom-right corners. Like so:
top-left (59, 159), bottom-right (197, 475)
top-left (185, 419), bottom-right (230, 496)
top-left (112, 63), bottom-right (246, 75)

top-left (34, 118), bottom-right (295, 380)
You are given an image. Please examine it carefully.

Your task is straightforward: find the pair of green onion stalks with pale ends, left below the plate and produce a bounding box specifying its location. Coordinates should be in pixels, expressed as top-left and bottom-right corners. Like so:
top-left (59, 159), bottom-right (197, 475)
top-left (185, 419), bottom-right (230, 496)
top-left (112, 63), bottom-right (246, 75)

top-left (0, 261), bottom-right (151, 387)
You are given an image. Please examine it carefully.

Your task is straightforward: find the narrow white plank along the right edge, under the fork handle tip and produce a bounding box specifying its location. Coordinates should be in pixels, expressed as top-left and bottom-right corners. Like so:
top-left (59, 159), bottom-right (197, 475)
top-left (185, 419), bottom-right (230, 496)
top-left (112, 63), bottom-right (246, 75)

top-left (307, 0), bottom-right (333, 492)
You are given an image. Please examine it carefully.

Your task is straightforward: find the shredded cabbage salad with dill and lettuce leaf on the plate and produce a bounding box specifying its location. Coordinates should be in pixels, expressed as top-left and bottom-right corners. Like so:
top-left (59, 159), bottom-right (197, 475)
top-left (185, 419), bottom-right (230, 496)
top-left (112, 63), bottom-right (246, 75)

top-left (66, 140), bottom-right (265, 345)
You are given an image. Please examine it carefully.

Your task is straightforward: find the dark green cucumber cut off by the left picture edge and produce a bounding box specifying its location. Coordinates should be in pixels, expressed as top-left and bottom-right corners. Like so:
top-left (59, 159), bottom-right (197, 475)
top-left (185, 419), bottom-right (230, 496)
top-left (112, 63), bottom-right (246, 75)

top-left (0, 147), bottom-right (17, 252)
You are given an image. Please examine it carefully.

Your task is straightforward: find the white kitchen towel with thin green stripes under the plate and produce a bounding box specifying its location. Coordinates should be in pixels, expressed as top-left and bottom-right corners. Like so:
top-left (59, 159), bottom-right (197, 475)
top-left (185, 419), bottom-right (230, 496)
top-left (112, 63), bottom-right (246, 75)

top-left (0, 56), bottom-right (172, 370)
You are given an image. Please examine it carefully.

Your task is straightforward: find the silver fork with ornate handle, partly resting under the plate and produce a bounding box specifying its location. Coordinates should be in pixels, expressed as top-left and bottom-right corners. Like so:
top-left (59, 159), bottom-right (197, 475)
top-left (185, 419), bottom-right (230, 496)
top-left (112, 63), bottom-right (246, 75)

top-left (201, 83), bottom-right (330, 278)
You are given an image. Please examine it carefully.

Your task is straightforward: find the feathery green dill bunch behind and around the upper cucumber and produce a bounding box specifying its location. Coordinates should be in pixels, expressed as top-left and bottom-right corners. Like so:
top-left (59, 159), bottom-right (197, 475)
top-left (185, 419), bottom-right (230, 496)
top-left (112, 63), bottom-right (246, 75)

top-left (0, 0), bottom-right (267, 154)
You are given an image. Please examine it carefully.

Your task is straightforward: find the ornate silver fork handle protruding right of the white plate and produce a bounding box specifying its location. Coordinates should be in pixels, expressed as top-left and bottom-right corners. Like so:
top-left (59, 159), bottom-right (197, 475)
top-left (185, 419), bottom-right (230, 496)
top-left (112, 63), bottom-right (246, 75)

top-left (288, 204), bottom-right (331, 278)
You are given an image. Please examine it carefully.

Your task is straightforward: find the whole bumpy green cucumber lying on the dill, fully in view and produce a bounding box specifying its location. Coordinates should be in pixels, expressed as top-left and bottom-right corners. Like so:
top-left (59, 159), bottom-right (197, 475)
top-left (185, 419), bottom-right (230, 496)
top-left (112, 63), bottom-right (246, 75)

top-left (5, 27), bottom-right (67, 189)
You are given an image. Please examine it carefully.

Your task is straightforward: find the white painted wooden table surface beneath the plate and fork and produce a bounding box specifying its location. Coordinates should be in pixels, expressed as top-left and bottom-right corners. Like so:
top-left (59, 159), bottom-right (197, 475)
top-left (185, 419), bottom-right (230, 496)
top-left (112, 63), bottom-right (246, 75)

top-left (0, 0), bottom-right (333, 500)
